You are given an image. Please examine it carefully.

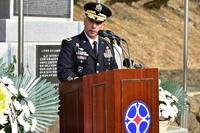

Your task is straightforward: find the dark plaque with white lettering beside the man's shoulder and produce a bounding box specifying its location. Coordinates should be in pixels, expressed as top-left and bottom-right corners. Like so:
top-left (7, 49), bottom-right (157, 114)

top-left (36, 45), bottom-right (60, 86)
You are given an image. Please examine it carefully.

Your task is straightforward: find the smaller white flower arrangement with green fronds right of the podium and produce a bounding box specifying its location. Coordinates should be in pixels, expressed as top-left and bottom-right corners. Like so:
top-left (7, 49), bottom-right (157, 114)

top-left (159, 80), bottom-right (188, 121)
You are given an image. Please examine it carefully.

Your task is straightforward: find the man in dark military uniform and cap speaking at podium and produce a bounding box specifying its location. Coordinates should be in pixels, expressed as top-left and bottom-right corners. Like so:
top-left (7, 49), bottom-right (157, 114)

top-left (57, 2), bottom-right (117, 82)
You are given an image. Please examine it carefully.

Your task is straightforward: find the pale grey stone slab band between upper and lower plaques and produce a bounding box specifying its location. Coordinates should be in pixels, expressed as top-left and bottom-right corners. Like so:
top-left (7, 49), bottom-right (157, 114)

top-left (0, 17), bottom-right (83, 42)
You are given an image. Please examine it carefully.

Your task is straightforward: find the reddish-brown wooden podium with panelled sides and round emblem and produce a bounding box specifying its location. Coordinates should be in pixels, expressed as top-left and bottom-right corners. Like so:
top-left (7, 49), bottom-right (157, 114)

top-left (59, 68), bottom-right (159, 133)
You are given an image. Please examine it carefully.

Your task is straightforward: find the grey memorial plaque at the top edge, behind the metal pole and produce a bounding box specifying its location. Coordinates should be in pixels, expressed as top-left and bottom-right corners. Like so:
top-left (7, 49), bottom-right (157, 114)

top-left (14, 0), bottom-right (71, 18)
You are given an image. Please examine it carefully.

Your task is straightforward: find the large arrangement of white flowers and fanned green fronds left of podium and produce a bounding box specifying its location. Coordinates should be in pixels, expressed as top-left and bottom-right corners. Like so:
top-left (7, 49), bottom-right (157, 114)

top-left (0, 58), bottom-right (59, 133)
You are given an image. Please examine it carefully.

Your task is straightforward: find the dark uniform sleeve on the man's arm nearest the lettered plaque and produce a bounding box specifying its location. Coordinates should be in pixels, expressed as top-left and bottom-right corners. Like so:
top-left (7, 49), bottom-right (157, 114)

top-left (57, 40), bottom-right (76, 82)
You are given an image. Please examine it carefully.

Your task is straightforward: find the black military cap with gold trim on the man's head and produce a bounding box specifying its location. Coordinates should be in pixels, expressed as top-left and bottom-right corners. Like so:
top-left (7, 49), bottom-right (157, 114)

top-left (84, 2), bottom-right (112, 22)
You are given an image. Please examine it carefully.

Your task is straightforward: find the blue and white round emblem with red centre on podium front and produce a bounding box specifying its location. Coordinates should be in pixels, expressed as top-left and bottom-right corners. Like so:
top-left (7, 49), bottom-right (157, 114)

top-left (124, 101), bottom-right (151, 133)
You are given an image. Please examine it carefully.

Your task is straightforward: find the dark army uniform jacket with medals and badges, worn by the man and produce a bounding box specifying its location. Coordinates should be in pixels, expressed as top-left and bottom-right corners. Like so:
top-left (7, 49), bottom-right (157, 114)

top-left (57, 32), bottom-right (117, 82)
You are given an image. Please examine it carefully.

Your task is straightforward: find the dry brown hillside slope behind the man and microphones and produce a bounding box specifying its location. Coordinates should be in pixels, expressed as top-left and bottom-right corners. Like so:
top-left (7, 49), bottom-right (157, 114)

top-left (74, 0), bottom-right (200, 86)
